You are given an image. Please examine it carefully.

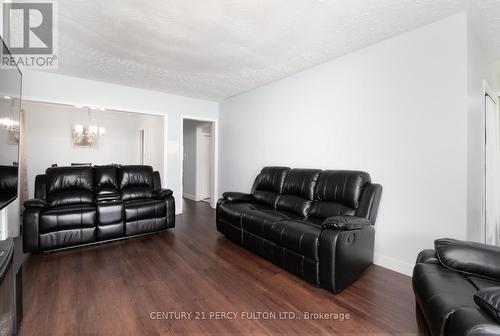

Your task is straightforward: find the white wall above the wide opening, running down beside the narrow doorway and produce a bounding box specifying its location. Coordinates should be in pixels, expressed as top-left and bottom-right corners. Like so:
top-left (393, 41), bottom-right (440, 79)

top-left (19, 71), bottom-right (218, 213)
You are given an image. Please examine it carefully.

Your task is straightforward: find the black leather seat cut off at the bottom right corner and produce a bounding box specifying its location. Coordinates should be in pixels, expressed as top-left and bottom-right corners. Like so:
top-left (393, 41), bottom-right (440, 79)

top-left (412, 239), bottom-right (500, 336)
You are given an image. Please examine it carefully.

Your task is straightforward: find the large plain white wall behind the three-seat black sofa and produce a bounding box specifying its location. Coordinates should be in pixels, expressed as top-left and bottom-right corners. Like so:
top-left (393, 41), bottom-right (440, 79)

top-left (219, 13), bottom-right (467, 274)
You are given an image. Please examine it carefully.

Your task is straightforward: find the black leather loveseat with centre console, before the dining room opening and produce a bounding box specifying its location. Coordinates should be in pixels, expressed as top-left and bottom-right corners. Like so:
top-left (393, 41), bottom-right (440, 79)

top-left (23, 165), bottom-right (175, 252)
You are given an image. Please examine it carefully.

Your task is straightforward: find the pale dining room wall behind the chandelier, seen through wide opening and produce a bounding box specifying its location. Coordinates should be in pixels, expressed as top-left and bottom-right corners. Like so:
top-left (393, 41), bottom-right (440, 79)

top-left (23, 100), bottom-right (164, 197)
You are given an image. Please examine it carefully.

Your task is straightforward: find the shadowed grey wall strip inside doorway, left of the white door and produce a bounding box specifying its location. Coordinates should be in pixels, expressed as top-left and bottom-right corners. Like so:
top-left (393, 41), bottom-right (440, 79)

top-left (183, 120), bottom-right (199, 200)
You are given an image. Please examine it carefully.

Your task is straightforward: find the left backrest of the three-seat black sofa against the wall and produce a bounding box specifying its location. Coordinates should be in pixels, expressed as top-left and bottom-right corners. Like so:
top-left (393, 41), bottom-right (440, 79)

top-left (252, 167), bottom-right (290, 208)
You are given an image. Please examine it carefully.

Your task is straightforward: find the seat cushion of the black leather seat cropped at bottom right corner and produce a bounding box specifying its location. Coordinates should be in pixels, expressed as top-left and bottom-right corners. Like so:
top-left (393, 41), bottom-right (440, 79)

top-left (413, 263), bottom-right (477, 335)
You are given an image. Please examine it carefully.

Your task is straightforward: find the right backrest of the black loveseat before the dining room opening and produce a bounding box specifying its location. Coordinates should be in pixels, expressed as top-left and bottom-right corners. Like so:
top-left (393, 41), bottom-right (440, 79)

top-left (118, 165), bottom-right (154, 201)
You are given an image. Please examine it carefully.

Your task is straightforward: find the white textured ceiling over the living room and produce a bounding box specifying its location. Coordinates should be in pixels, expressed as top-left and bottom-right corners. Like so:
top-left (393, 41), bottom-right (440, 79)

top-left (51, 0), bottom-right (500, 100)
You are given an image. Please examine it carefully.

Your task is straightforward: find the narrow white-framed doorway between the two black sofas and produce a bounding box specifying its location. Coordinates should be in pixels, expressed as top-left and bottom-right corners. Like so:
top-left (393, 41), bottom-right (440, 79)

top-left (182, 118), bottom-right (216, 207)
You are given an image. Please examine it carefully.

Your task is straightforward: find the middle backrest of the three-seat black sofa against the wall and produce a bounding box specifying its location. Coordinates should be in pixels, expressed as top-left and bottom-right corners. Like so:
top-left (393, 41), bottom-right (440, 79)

top-left (276, 169), bottom-right (321, 217)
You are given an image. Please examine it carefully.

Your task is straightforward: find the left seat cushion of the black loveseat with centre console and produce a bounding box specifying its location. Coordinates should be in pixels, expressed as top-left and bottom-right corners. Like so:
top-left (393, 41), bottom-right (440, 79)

top-left (40, 204), bottom-right (97, 232)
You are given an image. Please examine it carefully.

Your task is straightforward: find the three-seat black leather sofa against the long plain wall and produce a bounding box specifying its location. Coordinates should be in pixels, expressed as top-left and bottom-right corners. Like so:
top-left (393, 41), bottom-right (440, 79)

top-left (217, 167), bottom-right (382, 292)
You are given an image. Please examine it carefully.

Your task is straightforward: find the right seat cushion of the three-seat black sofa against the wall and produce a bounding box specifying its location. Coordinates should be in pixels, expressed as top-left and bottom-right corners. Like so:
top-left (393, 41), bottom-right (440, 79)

top-left (268, 220), bottom-right (321, 261)
